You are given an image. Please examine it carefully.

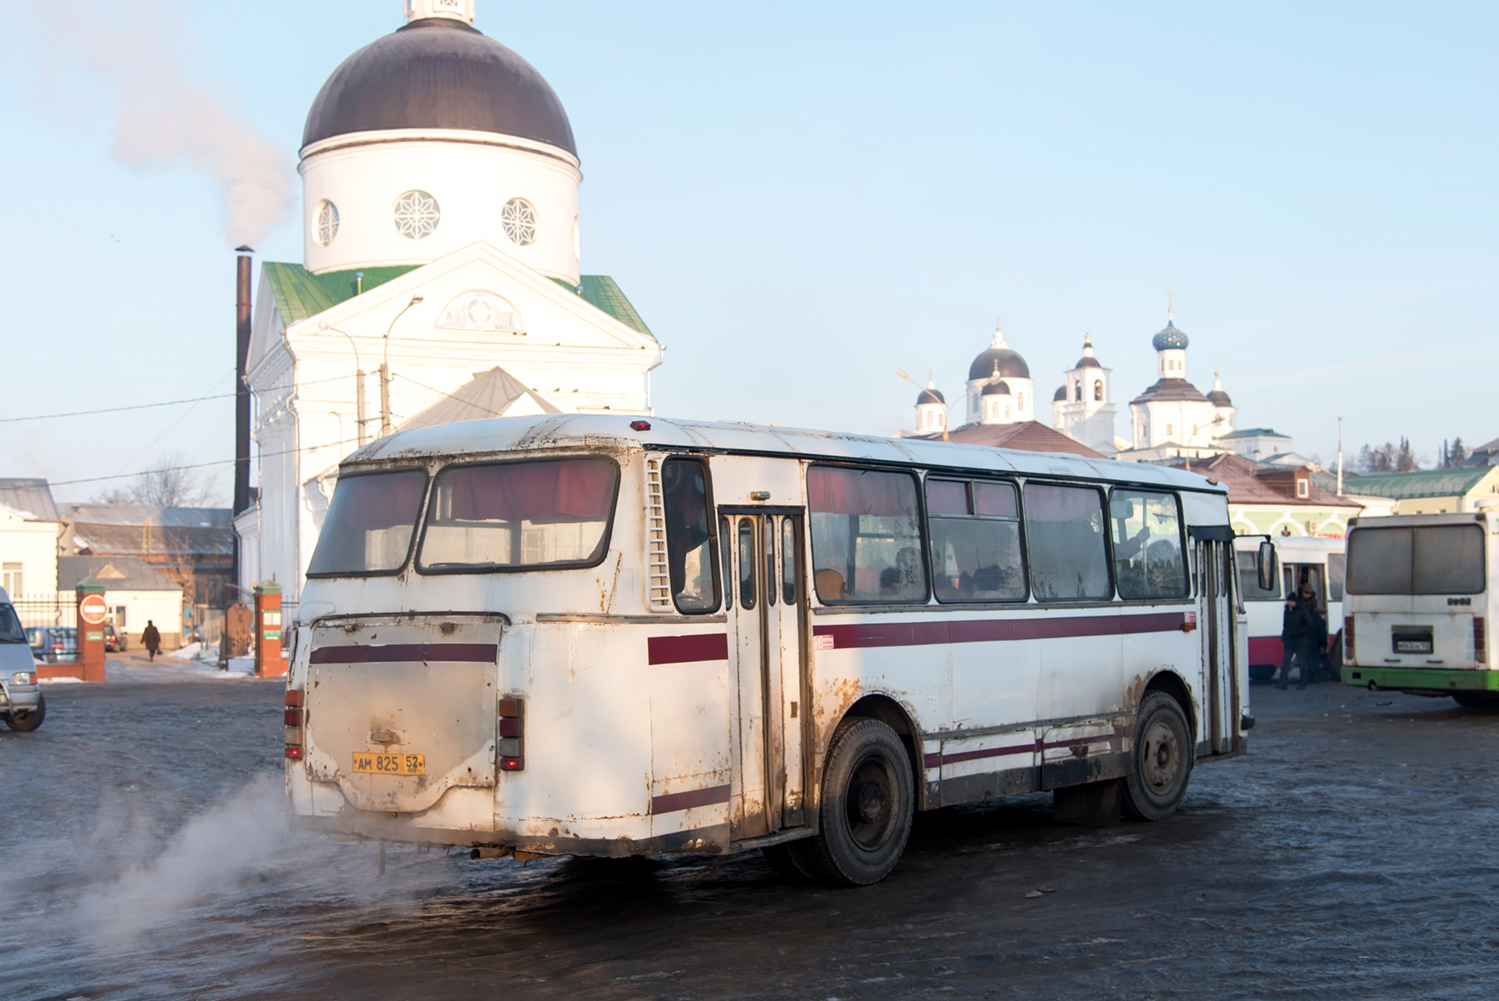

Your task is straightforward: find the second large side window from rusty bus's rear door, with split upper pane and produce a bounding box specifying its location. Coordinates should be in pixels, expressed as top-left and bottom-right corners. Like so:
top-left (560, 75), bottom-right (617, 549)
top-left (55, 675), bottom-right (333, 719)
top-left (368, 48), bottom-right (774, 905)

top-left (926, 480), bottom-right (1025, 601)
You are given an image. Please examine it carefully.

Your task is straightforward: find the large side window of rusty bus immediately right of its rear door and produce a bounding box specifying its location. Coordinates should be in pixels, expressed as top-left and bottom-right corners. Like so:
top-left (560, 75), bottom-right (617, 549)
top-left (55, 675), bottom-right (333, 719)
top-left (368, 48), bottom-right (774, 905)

top-left (806, 466), bottom-right (926, 604)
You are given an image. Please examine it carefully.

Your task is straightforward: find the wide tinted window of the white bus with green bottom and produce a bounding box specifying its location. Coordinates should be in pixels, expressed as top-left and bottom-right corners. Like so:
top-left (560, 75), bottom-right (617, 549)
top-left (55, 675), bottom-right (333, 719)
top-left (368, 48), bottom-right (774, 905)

top-left (1348, 524), bottom-right (1484, 595)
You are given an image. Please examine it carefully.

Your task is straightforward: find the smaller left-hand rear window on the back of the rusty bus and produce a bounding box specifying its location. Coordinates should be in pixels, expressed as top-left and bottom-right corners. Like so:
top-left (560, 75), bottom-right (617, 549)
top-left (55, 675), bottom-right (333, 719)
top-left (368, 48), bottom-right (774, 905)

top-left (307, 469), bottom-right (427, 577)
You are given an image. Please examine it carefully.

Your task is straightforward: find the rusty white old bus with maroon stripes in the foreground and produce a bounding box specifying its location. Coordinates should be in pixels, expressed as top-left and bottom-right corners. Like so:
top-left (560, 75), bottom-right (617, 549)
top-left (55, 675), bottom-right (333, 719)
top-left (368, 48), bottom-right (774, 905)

top-left (285, 415), bottom-right (1253, 884)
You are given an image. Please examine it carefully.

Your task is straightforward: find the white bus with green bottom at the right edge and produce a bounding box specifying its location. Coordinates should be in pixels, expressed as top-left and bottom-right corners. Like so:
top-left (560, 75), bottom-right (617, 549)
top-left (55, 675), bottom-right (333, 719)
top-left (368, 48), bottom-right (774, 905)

top-left (1343, 511), bottom-right (1499, 707)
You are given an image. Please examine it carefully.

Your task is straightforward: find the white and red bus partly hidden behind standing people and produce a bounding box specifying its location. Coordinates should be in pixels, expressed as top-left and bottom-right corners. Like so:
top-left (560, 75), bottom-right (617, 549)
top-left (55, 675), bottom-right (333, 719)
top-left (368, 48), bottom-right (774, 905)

top-left (1234, 536), bottom-right (1346, 682)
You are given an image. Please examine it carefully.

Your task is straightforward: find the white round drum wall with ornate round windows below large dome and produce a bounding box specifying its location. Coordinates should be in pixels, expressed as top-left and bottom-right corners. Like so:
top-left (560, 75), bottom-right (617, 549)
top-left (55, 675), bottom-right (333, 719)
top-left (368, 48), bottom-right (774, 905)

top-left (300, 130), bottom-right (583, 285)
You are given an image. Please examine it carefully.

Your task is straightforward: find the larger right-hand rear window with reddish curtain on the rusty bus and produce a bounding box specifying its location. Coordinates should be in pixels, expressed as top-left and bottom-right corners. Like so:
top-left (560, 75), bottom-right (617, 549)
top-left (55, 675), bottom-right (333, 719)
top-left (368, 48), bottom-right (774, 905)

top-left (417, 459), bottom-right (619, 574)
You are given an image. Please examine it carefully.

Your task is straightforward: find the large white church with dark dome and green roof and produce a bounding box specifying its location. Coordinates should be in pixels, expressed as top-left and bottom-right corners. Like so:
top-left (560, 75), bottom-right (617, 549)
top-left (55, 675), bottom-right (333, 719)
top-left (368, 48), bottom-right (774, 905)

top-left (234, 0), bottom-right (663, 604)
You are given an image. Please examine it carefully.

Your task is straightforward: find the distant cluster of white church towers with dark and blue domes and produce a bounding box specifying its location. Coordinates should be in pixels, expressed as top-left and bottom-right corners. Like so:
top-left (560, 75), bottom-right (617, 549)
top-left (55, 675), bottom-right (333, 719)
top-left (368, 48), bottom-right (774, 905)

top-left (905, 310), bottom-right (1238, 462)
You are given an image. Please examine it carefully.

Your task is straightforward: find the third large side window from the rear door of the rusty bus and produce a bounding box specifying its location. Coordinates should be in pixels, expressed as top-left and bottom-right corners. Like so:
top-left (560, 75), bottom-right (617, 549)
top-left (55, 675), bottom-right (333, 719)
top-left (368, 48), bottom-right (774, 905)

top-left (1025, 483), bottom-right (1114, 601)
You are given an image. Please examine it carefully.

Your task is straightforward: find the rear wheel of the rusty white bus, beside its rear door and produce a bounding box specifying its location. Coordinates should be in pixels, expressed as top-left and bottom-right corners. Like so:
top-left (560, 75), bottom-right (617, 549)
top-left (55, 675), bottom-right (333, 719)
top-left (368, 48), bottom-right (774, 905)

top-left (793, 719), bottom-right (916, 886)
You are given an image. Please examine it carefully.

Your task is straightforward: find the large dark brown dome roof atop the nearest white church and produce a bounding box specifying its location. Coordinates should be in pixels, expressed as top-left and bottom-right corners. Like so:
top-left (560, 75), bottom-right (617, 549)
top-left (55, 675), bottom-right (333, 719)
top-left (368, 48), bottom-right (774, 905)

top-left (301, 18), bottom-right (577, 156)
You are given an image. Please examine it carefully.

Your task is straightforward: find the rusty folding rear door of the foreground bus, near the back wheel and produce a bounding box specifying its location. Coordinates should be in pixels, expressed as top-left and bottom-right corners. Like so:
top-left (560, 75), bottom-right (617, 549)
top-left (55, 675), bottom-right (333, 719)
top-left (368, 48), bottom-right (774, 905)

top-left (718, 508), bottom-right (808, 839)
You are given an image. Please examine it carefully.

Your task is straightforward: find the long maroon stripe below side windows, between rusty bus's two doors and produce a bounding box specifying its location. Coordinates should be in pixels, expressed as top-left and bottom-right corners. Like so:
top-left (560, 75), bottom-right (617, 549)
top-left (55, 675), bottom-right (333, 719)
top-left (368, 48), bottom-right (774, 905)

top-left (812, 611), bottom-right (1186, 649)
